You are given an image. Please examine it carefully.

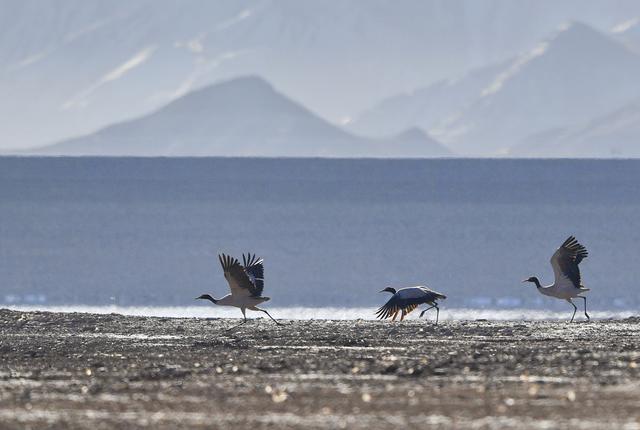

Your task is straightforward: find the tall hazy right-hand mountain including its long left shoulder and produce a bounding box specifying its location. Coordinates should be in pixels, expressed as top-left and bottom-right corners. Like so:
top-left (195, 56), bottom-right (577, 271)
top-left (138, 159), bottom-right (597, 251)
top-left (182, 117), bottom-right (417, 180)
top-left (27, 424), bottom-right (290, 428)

top-left (352, 22), bottom-right (640, 157)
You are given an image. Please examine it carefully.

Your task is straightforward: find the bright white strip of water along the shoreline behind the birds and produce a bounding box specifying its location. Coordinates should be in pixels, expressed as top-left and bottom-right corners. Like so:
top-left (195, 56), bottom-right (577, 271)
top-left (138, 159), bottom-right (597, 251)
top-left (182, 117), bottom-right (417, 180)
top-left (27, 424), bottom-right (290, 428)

top-left (0, 305), bottom-right (639, 321)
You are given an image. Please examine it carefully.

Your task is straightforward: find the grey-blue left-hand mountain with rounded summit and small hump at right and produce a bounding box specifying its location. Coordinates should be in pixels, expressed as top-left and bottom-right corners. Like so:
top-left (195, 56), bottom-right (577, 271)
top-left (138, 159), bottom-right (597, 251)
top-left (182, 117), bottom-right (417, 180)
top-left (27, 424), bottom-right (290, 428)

top-left (30, 77), bottom-right (451, 157)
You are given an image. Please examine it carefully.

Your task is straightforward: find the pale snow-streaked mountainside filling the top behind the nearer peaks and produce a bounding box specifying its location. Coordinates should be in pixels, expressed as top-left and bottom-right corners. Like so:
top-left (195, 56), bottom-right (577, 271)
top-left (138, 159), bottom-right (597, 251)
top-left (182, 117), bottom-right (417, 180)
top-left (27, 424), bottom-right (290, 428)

top-left (0, 0), bottom-right (640, 152)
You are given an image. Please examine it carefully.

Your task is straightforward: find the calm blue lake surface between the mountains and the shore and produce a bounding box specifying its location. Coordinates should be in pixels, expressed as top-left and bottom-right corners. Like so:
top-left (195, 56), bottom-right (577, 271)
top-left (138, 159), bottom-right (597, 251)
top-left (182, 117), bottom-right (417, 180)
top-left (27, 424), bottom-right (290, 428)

top-left (0, 157), bottom-right (640, 312)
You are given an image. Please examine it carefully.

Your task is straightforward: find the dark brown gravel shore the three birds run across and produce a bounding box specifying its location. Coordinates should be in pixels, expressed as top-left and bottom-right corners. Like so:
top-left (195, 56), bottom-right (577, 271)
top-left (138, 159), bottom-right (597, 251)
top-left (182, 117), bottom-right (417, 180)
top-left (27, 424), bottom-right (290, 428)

top-left (0, 310), bottom-right (640, 430)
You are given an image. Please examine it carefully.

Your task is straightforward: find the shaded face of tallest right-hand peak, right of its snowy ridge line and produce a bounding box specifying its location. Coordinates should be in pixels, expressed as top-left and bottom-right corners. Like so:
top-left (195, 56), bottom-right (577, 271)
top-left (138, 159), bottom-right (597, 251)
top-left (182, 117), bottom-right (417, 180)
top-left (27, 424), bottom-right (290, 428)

top-left (430, 23), bottom-right (640, 155)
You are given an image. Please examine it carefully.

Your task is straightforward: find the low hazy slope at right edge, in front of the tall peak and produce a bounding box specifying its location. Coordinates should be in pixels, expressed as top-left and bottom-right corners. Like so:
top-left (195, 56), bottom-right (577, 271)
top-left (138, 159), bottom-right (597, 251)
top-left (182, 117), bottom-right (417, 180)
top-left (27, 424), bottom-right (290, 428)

top-left (509, 99), bottom-right (640, 158)
